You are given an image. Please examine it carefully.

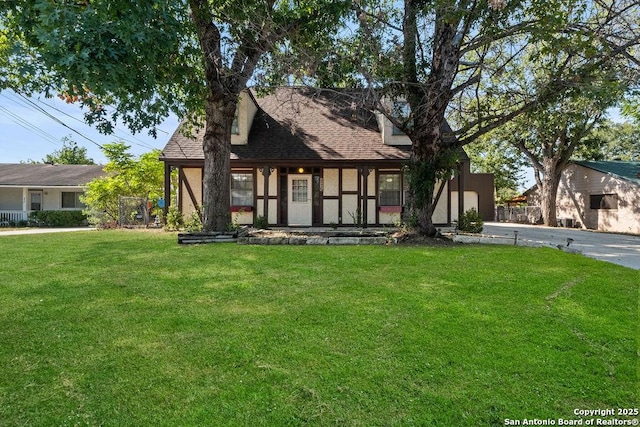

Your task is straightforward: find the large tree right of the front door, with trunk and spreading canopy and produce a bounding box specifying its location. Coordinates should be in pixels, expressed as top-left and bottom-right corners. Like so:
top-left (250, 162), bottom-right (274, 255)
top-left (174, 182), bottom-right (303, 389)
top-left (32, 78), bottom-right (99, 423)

top-left (278, 0), bottom-right (640, 234)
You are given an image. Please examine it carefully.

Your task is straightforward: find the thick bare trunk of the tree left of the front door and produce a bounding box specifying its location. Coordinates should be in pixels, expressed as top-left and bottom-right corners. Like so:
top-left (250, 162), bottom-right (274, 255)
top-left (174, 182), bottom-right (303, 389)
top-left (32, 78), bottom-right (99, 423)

top-left (202, 95), bottom-right (236, 231)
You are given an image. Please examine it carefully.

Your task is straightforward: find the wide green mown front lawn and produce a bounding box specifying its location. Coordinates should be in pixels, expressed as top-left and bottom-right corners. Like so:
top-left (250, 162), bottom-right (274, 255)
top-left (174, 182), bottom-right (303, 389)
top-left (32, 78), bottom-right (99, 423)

top-left (0, 231), bottom-right (640, 426)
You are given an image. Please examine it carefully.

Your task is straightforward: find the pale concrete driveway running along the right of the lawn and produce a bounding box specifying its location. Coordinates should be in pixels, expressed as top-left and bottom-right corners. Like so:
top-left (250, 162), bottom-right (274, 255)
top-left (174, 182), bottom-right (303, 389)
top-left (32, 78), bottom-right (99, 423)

top-left (482, 222), bottom-right (640, 270)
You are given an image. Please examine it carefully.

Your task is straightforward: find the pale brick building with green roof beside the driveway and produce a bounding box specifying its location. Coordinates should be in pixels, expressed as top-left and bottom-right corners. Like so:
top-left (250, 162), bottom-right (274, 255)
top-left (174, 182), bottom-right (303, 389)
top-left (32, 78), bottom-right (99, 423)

top-left (529, 161), bottom-right (640, 234)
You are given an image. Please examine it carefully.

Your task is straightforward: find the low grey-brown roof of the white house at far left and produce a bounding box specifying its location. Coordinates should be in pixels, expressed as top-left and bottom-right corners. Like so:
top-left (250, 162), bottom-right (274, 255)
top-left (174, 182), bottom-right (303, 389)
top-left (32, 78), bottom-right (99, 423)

top-left (0, 163), bottom-right (106, 187)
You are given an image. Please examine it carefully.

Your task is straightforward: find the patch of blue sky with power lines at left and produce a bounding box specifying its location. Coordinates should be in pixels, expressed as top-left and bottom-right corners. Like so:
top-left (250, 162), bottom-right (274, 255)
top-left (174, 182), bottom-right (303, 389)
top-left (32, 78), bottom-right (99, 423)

top-left (0, 90), bottom-right (178, 164)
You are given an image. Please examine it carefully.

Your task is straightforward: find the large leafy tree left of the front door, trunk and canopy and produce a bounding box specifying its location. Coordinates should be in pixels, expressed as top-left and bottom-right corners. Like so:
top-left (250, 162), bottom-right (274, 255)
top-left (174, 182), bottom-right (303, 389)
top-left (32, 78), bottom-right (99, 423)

top-left (0, 0), bottom-right (348, 230)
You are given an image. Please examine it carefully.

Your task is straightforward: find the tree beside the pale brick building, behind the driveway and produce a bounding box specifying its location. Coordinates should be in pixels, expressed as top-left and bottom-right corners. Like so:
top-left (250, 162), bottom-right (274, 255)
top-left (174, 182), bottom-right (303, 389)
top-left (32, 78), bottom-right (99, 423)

top-left (480, 14), bottom-right (638, 226)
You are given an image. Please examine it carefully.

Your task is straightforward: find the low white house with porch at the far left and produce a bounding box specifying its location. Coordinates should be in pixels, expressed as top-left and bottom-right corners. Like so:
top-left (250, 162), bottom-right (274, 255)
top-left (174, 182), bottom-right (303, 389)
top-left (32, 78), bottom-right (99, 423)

top-left (0, 163), bottom-right (105, 225)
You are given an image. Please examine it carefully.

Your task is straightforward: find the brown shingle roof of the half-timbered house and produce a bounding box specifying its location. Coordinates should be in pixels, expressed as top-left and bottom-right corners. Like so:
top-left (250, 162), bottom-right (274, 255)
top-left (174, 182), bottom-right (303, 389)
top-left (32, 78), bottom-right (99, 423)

top-left (160, 88), bottom-right (460, 163)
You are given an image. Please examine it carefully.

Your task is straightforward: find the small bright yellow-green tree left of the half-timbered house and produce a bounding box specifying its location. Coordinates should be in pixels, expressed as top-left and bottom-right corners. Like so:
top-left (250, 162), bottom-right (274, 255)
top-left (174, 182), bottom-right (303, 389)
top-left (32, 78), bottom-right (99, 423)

top-left (82, 142), bottom-right (164, 225)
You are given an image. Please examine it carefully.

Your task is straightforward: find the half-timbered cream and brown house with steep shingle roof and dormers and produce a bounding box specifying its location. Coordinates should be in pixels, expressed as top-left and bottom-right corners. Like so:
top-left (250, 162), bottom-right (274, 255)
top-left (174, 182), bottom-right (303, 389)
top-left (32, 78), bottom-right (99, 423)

top-left (160, 88), bottom-right (494, 226)
